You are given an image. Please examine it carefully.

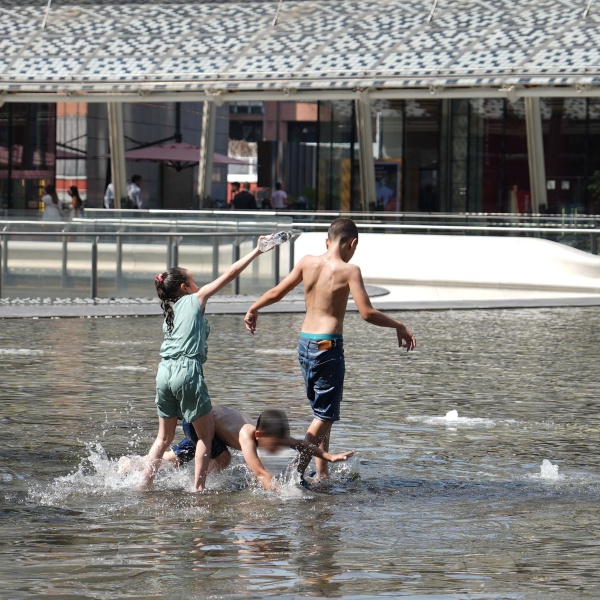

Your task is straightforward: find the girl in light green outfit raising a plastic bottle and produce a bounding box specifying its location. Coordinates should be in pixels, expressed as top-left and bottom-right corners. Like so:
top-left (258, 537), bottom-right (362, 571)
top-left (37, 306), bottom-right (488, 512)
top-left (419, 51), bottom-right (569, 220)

top-left (142, 238), bottom-right (262, 492)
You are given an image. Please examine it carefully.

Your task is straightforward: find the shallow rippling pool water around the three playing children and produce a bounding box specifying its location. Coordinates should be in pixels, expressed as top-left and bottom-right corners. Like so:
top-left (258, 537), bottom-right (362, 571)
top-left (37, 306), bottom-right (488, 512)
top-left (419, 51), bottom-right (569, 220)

top-left (0, 308), bottom-right (600, 599)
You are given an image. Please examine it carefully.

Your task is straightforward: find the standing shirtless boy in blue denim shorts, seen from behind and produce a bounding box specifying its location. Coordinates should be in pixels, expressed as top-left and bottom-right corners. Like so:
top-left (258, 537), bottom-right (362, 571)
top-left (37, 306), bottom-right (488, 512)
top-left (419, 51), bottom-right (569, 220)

top-left (244, 219), bottom-right (416, 478)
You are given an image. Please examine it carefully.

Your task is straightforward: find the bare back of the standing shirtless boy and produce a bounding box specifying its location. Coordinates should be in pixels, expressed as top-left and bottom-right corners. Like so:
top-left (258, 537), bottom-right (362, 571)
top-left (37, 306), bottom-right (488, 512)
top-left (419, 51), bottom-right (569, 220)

top-left (299, 252), bottom-right (358, 335)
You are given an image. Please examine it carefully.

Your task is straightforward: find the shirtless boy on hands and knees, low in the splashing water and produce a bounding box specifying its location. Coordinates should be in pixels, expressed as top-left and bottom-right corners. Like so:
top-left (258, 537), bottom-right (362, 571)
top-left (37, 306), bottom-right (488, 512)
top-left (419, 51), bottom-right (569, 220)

top-left (163, 406), bottom-right (354, 490)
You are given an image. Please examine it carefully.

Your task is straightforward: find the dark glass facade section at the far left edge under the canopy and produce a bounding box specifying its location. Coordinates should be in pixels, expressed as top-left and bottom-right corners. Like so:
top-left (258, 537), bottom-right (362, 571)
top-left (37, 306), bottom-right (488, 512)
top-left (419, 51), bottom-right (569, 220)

top-left (0, 103), bottom-right (56, 211)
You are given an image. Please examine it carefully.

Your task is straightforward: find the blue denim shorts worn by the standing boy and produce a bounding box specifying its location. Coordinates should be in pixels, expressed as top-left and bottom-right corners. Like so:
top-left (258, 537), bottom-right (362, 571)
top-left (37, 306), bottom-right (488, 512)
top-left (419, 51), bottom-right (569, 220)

top-left (298, 335), bottom-right (346, 421)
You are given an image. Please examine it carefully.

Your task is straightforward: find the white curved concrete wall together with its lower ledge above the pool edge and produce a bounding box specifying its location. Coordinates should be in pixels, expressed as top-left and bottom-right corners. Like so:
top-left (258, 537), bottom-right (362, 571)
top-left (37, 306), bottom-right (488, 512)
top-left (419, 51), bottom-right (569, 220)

top-left (295, 233), bottom-right (600, 305)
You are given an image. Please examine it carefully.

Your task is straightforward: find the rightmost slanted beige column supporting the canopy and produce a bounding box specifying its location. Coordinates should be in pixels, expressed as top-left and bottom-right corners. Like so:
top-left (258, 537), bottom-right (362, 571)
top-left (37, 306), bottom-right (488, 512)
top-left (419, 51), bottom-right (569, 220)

top-left (524, 97), bottom-right (548, 213)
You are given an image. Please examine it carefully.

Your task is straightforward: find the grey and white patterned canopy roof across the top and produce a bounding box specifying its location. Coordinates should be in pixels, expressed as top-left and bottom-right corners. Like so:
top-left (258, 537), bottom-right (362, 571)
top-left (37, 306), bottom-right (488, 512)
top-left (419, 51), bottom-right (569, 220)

top-left (0, 0), bottom-right (600, 92)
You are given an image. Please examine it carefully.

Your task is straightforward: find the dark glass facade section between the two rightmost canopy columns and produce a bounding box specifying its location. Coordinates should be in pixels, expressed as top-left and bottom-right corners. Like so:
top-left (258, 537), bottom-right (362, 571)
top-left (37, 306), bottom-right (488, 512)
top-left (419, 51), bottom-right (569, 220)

top-left (372, 99), bottom-right (529, 217)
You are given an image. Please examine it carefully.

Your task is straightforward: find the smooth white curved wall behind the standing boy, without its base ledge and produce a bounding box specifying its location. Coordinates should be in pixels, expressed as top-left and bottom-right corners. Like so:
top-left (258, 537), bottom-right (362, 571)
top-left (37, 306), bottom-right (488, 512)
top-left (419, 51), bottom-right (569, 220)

top-left (296, 233), bottom-right (600, 294)
